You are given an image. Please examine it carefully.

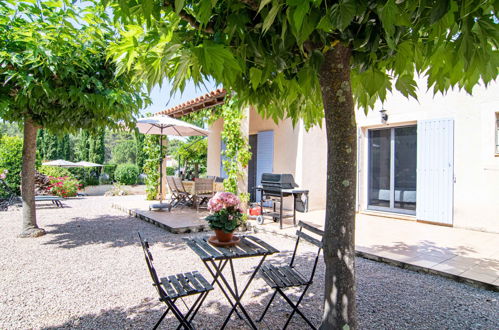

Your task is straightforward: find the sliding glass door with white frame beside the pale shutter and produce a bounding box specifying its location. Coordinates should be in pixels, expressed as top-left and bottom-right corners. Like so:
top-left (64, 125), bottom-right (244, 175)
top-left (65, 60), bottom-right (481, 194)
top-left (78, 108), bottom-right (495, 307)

top-left (368, 125), bottom-right (417, 214)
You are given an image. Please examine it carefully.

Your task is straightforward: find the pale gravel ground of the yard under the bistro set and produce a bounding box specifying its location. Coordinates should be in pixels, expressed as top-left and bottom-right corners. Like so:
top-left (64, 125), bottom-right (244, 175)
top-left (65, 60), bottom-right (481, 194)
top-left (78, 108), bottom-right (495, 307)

top-left (0, 197), bottom-right (499, 329)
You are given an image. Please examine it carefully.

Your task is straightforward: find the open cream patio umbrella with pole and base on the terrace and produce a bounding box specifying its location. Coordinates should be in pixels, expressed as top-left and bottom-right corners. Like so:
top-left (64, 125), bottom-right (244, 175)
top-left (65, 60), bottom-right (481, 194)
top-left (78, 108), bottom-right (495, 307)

top-left (137, 115), bottom-right (209, 209)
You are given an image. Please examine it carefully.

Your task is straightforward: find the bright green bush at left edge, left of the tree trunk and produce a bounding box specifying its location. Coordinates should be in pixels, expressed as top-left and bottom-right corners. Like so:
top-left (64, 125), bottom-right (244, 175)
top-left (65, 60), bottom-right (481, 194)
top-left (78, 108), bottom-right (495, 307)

top-left (0, 136), bottom-right (23, 197)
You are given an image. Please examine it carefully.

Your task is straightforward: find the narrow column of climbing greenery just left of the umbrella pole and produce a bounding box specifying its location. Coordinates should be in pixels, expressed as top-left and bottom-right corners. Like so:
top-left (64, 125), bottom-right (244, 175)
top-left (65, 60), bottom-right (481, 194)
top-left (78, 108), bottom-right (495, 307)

top-left (144, 135), bottom-right (160, 200)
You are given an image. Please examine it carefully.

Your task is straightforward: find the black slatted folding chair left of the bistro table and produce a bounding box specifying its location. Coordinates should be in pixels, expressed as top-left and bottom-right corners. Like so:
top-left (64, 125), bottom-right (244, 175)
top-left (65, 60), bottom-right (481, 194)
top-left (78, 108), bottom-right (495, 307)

top-left (138, 233), bottom-right (213, 329)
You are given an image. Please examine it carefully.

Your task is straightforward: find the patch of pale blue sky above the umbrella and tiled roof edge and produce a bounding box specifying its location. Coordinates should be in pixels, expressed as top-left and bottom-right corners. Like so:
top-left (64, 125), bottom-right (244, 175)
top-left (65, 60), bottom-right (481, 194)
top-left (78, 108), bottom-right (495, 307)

top-left (141, 80), bottom-right (217, 114)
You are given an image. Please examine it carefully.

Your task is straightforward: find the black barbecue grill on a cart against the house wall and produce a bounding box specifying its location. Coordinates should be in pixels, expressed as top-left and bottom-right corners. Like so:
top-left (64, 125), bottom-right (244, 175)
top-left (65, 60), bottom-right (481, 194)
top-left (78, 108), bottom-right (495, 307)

top-left (256, 173), bottom-right (308, 229)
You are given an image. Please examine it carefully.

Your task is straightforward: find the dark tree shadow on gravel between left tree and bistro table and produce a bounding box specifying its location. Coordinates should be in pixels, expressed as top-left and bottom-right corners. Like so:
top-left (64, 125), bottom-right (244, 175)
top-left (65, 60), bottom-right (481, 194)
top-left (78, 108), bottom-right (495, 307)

top-left (43, 215), bottom-right (205, 250)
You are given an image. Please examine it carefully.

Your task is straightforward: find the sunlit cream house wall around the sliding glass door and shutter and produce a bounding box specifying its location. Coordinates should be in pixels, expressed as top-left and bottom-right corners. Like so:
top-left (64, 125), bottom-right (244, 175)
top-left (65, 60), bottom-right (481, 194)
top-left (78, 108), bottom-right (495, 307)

top-left (357, 81), bottom-right (499, 232)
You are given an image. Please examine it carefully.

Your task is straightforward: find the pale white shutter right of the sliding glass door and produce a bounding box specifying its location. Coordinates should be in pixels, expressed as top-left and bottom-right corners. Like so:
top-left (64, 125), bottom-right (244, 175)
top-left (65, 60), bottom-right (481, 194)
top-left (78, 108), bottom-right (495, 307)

top-left (416, 119), bottom-right (454, 225)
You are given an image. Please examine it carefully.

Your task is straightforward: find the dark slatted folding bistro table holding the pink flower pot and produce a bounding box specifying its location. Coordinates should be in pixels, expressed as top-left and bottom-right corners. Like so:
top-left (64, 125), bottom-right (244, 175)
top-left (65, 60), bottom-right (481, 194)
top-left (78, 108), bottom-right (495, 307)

top-left (184, 235), bottom-right (279, 329)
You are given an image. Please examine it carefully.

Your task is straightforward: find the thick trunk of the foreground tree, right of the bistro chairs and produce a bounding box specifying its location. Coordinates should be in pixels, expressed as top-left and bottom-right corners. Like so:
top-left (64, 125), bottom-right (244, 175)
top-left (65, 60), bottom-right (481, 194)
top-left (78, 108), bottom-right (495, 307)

top-left (319, 43), bottom-right (357, 329)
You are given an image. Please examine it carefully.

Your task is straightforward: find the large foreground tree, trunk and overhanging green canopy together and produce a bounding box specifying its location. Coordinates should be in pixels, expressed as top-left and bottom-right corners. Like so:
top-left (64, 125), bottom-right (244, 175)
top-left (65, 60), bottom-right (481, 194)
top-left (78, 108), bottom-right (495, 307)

top-left (105, 0), bottom-right (499, 329)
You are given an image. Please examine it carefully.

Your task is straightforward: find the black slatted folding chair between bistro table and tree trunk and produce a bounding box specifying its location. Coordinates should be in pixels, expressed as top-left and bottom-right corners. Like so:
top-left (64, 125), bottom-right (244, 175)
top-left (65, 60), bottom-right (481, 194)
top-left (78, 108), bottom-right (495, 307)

top-left (258, 221), bottom-right (324, 329)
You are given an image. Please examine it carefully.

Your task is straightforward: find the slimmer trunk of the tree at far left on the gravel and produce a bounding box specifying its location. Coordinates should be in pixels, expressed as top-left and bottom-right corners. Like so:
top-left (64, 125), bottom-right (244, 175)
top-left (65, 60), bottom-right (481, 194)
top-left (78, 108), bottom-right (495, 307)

top-left (19, 118), bottom-right (45, 237)
